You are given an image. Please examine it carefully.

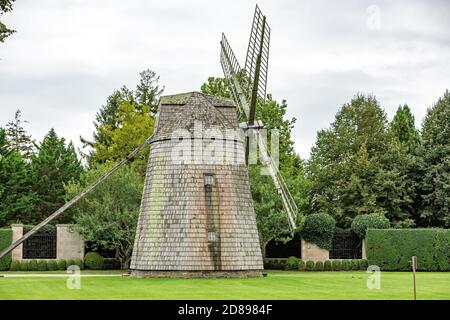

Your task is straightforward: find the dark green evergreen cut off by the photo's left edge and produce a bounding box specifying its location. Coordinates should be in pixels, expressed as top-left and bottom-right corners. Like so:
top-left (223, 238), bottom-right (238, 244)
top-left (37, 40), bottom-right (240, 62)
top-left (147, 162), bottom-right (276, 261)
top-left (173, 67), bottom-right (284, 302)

top-left (0, 128), bottom-right (34, 227)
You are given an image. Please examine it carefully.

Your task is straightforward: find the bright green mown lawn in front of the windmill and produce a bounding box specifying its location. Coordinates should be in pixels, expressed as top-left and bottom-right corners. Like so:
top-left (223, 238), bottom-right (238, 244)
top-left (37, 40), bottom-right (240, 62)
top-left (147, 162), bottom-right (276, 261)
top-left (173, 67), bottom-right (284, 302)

top-left (0, 271), bottom-right (450, 299)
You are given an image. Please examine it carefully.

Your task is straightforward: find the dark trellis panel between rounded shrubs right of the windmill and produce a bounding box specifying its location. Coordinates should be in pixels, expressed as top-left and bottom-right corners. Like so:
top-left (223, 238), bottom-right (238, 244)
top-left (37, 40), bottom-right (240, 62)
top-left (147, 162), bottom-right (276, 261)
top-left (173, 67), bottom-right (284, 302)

top-left (330, 231), bottom-right (362, 259)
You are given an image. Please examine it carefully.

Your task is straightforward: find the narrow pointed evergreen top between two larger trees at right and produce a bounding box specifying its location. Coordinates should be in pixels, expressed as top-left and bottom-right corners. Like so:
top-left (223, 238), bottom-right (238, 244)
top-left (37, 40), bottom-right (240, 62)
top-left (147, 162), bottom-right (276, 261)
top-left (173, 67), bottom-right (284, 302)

top-left (390, 104), bottom-right (420, 154)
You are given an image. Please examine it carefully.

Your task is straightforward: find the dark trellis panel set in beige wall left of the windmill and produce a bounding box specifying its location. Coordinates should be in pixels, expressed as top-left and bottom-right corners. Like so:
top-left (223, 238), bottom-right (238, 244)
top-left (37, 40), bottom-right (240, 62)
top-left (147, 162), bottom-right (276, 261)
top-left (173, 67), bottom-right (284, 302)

top-left (22, 229), bottom-right (56, 259)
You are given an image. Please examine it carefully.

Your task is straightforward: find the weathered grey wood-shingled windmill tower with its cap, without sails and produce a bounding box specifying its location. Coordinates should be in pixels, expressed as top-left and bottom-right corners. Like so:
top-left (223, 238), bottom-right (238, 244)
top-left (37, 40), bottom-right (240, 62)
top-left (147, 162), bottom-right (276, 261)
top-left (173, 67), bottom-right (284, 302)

top-left (130, 92), bottom-right (263, 277)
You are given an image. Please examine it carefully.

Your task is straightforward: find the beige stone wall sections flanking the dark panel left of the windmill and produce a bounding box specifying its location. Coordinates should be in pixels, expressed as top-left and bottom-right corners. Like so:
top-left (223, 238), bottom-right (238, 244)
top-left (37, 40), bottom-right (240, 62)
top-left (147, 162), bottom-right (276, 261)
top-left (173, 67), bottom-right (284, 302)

top-left (11, 224), bottom-right (84, 261)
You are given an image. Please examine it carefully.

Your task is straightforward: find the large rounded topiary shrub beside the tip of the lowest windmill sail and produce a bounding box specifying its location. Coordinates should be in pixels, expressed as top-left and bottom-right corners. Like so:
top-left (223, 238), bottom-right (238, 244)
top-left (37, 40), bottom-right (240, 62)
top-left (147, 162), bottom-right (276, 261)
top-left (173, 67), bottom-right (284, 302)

top-left (300, 213), bottom-right (336, 250)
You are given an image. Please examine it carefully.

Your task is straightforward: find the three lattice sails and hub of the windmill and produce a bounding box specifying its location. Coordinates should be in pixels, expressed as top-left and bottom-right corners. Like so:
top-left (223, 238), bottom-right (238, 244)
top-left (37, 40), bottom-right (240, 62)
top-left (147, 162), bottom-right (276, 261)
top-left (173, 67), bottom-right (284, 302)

top-left (220, 5), bottom-right (298, 233)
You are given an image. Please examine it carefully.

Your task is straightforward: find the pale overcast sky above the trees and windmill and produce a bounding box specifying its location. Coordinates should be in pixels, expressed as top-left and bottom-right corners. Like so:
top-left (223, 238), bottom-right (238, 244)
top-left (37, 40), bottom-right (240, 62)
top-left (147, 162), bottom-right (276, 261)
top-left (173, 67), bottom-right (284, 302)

top-left (0, 0), bottom-right (450, 158)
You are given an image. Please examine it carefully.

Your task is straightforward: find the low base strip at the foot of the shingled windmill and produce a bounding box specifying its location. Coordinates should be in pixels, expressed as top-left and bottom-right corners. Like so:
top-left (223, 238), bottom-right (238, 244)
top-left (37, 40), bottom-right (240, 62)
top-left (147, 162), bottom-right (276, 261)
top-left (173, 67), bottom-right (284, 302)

top-left (131, 270), bottom-right (263, 278)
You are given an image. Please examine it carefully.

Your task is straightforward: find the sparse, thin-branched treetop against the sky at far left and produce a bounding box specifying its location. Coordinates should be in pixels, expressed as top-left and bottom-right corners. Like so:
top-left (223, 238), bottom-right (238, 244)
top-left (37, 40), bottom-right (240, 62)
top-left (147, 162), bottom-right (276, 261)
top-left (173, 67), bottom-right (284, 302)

top-left (6, 110), bottom-right (34, 159)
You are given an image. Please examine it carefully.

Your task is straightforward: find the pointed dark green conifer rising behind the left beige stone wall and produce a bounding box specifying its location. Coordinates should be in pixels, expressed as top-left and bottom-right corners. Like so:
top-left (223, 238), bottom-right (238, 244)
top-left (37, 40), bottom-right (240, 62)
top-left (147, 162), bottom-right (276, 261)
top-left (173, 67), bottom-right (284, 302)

top-left (29, 129), bottom-right (83, 223)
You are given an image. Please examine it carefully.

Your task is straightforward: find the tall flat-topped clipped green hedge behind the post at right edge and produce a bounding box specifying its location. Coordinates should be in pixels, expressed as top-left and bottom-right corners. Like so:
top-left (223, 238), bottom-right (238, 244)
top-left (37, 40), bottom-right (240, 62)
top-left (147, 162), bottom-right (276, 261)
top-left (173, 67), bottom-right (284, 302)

top-left (366, 229), bottom-right (450, 271)
